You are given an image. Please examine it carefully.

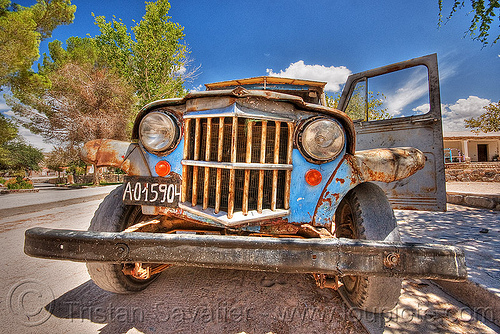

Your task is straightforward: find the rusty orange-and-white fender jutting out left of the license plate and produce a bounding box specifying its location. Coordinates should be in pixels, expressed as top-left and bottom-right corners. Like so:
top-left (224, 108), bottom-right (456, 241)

top-left (81, 139), bottom-right (150, 175)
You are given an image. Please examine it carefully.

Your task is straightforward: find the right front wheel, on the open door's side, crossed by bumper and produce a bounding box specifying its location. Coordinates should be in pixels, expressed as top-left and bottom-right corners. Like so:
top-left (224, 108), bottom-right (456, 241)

top-left (335, 183), bottom-right (402, 313)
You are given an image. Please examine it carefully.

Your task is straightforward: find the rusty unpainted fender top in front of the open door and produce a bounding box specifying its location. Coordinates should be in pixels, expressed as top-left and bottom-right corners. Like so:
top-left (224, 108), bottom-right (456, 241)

top-left (351, 147), bottom-right (425, 182)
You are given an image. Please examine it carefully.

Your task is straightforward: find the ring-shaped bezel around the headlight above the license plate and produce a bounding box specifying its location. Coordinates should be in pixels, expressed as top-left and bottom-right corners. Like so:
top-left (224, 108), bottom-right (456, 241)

top-left (138, 110), bottom-right (181, 155)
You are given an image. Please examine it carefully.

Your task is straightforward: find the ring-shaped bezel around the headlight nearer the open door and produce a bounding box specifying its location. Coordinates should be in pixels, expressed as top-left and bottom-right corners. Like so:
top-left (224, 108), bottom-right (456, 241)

top-left (296, 116), bottom-right (347, 165)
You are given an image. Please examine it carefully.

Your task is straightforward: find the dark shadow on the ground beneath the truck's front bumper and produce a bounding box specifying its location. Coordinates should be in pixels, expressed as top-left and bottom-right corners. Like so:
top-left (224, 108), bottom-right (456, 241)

top-left (46, 267), bottom-right (365, 334)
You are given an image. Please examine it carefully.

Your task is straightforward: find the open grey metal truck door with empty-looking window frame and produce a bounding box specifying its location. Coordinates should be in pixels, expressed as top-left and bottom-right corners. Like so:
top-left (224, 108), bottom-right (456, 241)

top-left (339, 54), bottom-right (446, 211)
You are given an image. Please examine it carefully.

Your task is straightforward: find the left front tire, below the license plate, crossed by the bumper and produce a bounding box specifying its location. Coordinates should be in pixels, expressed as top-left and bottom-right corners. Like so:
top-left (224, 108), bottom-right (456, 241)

top-left (87, 185), bottom-right (160, 294)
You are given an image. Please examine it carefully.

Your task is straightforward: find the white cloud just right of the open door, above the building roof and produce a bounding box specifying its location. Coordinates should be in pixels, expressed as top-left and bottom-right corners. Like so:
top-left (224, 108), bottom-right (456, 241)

top-left (441, 96), bottom-right (491, 131)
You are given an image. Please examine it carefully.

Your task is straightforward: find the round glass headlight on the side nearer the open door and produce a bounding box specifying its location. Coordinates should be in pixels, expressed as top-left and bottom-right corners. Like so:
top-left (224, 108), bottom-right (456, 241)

top-left (302, 118), bottom-right (344, 161)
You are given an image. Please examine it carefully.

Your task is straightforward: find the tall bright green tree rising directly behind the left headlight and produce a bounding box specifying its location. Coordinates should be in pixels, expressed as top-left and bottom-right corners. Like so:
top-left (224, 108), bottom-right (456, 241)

top-left (95, 0), bottom-right (194, 106)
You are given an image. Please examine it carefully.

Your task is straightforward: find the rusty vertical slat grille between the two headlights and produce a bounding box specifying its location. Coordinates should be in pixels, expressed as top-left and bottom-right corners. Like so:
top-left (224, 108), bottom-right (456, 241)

top-left (182, 117), bottom-right (293, 219)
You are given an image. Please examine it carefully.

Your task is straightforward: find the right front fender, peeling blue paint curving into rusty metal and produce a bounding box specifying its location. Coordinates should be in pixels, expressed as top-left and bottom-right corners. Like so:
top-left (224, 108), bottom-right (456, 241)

top-left (313, 147), bottom-right (425, 229)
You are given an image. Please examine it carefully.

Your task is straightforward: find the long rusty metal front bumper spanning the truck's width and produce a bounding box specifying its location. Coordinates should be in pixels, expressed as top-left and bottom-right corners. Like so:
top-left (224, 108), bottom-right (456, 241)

top-left (24, 227), bottom-right (467, 280)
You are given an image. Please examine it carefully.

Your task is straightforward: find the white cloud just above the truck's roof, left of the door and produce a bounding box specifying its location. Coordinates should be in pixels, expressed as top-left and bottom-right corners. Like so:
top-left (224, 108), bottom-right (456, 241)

top-left (266, 60), bottom-right (352, 92)
